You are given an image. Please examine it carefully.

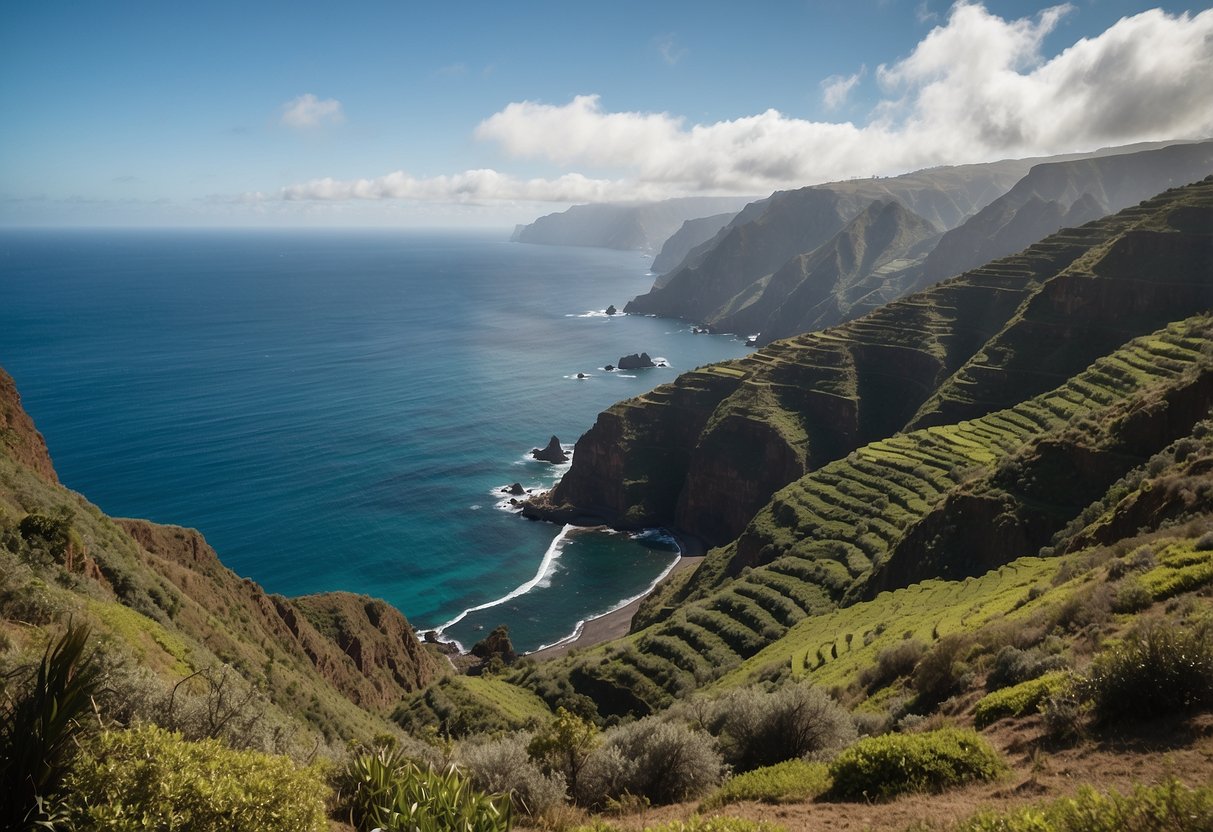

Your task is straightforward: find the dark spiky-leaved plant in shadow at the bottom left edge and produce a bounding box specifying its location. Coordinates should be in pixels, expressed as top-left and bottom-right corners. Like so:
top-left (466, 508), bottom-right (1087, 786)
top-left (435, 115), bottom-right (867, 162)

top-left (0, 625), bottom-right (99, 830)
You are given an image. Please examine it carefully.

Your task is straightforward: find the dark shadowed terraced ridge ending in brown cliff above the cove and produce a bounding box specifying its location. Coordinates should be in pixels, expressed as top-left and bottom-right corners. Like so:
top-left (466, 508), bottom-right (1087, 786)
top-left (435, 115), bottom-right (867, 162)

top-left (528, 179), bottom-right (1213, 545)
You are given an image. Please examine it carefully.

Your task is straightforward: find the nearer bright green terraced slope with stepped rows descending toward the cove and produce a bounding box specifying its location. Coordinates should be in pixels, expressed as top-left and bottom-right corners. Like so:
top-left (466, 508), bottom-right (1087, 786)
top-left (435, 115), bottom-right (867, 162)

top-left (543, 314), bottom-right (1213, 713)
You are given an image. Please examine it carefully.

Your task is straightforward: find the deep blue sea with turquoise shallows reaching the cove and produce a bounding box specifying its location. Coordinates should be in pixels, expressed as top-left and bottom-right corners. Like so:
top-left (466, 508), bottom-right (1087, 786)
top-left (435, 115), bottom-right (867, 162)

top-left (0, 230), bottom-right (745, 650)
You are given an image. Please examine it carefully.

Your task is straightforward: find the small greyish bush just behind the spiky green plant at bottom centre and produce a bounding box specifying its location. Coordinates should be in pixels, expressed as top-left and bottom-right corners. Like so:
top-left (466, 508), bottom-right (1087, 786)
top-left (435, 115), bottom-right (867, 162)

top-left (457, 734), bottom-right (566, 817)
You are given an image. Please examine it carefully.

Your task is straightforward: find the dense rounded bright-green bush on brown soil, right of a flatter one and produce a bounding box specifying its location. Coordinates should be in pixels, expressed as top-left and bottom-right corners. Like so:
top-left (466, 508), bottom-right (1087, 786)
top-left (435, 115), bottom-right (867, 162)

top-left (830, 728), bottom-right (1007, 800)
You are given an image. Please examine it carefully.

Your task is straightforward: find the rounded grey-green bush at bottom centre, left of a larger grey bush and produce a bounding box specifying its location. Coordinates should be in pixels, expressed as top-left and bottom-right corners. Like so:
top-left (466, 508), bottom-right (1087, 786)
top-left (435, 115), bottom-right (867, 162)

top-left (583, 717), bottom-right (724, 804)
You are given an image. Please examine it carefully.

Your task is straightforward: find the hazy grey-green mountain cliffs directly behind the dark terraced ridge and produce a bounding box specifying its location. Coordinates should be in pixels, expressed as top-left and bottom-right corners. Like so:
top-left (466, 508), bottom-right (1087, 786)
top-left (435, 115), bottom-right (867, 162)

top-left (626, 142), bottom-right (1213, 343)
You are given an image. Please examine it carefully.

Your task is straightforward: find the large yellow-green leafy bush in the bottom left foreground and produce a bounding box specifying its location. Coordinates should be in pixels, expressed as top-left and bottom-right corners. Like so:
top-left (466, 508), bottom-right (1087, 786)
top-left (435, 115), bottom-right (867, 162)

top-left (69, 725), bottom-right (329, 832)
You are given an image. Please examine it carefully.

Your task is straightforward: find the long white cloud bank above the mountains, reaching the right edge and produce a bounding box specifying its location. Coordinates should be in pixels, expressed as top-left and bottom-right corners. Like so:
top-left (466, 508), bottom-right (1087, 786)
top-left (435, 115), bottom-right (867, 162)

top-left (283, 1), bottom-right (1213, 201)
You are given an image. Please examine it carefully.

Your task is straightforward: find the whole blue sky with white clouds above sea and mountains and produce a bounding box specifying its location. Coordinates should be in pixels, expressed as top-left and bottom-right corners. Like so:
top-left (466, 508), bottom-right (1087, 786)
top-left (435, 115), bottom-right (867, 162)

top-left (0, 0), bottom-right (1213, 226)
